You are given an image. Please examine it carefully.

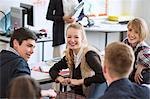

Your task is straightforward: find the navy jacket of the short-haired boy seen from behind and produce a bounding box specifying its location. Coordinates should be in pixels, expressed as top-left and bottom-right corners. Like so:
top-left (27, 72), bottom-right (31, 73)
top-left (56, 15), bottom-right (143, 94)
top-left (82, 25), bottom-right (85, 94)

top-left (99, 78), bottom-right (150, 99)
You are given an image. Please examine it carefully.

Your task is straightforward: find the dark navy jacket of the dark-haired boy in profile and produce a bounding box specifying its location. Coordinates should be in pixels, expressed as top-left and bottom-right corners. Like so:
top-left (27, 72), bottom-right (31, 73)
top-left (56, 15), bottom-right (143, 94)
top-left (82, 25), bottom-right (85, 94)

top-left (0, 50), bottom-right (30, 98)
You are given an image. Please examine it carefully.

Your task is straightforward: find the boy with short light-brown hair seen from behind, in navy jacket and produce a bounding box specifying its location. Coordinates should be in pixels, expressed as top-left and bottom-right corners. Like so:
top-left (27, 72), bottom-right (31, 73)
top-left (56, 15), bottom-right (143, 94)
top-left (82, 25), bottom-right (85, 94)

top-left (99, 42), bottom-right (150, 99)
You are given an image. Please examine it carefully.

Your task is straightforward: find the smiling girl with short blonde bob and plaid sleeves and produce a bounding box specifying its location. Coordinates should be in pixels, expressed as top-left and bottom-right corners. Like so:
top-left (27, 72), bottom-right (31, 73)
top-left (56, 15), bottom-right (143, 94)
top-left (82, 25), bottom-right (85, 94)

top-left (124, 18), bottom-right (150, 84)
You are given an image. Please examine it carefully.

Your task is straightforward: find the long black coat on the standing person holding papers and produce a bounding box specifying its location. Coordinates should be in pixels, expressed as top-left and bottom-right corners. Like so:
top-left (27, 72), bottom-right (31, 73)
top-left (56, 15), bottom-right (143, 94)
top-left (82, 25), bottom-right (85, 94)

top-left (46, 0), bottom-right (65, 46)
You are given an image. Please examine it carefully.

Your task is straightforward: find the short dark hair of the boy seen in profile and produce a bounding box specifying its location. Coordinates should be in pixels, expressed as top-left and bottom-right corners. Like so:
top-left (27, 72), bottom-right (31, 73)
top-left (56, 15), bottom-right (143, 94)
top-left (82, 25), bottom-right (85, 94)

top-left (10, 27), bottom-right (37, 47)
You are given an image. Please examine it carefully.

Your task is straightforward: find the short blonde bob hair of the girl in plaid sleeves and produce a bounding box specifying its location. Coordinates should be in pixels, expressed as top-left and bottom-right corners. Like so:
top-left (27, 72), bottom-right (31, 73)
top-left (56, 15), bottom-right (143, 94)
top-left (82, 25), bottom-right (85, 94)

top-left (127, 18), bottom-right (149, 41)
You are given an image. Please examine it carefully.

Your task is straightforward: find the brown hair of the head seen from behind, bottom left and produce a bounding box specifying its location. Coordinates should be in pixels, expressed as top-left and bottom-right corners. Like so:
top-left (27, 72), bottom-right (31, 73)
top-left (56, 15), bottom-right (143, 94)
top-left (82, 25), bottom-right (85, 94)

top-left (8, 75), bottom-right (41, 99)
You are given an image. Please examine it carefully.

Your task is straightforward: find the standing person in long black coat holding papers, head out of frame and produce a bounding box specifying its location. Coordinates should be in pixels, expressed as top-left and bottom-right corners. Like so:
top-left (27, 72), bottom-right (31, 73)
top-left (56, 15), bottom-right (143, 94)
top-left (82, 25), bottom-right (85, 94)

top-left (46, 0), bottom-right (81, 58)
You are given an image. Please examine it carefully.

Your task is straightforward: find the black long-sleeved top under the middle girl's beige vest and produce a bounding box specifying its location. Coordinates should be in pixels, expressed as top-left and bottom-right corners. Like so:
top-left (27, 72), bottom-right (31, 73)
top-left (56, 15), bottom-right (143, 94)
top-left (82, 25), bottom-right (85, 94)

top-left (49, 51), bottom-right (105, 95)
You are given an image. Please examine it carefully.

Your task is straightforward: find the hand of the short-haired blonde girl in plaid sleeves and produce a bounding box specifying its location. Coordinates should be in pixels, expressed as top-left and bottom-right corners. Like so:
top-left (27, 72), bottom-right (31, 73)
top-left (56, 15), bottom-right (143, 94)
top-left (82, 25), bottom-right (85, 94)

top-left (134, 64), bottom-right (145, 84)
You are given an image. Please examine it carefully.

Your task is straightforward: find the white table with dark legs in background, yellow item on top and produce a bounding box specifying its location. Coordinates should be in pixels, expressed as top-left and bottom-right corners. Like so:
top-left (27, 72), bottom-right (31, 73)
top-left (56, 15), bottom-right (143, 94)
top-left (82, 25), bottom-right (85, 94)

top-left (85, 23), bottom-right (127, 47)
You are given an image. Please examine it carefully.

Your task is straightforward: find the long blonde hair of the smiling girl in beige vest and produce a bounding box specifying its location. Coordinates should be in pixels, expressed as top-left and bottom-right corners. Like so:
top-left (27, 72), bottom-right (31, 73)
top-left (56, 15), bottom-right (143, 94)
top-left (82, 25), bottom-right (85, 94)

top-left (65, 22), bottom-right (88, 67)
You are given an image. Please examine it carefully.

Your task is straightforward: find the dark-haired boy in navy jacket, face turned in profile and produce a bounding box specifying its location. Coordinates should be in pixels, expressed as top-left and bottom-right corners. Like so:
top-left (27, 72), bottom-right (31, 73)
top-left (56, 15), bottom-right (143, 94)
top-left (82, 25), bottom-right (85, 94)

top-left (0, 28), bottom-right (37, 98)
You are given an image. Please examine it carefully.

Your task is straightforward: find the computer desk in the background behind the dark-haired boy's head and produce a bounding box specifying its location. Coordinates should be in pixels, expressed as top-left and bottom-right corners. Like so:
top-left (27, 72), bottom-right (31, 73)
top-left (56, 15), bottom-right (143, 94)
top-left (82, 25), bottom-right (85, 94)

top-left (0, 36), bottom-right (52, 61)
